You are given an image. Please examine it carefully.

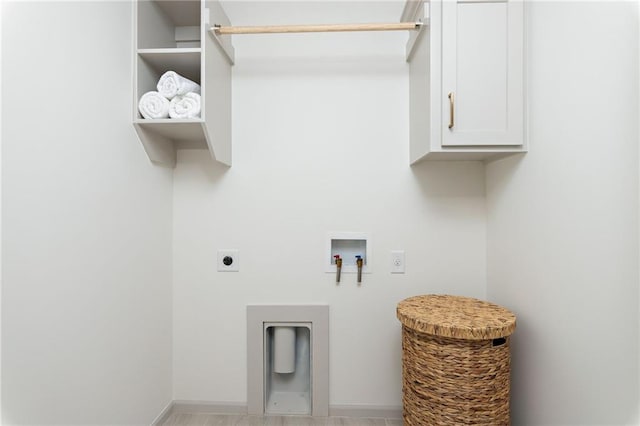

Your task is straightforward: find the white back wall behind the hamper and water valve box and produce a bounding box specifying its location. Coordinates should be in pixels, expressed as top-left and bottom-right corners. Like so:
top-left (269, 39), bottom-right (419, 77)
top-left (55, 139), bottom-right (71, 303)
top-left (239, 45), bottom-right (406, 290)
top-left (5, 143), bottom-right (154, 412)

top-left (174, 2), bottom-right (486, 407)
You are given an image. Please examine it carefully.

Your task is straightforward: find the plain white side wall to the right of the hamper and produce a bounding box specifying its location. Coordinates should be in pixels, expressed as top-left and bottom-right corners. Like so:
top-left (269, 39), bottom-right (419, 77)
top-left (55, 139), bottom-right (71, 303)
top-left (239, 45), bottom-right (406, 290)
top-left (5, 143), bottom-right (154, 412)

top-left (487, 2), bottom-right (640, 426)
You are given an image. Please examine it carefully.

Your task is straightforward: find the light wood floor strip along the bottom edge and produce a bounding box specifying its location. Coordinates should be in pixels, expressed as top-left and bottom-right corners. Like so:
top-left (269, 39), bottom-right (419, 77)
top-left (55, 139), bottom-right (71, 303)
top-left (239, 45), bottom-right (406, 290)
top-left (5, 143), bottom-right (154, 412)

top-left (163, 413), bottom-right (402, 426)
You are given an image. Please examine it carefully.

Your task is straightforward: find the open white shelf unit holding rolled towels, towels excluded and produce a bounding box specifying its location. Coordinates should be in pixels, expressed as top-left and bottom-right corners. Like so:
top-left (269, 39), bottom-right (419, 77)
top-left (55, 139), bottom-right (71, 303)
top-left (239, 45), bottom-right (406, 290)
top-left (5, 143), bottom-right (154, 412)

top-left (133, 0), bottom-right (233, 167)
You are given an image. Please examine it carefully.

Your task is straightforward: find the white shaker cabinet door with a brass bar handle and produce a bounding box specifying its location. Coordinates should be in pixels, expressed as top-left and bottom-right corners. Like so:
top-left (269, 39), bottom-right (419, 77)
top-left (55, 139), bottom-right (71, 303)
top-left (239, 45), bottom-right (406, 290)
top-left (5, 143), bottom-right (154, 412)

top-left (442, 0), bottom-right (524, 146)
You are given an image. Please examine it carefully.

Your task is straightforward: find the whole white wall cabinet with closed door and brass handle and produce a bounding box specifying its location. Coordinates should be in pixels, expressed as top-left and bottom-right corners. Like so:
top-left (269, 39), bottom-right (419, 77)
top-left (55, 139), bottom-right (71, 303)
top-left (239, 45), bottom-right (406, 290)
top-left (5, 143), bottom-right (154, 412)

top-left (402, 0), bottom-right (526, 163)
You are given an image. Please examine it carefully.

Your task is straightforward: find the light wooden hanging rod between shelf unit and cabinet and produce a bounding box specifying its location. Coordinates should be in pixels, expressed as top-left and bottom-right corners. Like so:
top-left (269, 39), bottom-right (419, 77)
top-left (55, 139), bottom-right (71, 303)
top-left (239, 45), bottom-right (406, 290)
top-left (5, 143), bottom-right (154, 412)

top-left (209, 22), bottom-right (422, 35)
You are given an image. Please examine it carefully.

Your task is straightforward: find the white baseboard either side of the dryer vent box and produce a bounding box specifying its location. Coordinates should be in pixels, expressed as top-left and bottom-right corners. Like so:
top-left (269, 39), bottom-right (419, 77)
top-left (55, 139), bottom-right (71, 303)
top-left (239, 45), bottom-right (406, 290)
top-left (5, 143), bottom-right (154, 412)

top-left (152, 400), bottom-right (402, 426)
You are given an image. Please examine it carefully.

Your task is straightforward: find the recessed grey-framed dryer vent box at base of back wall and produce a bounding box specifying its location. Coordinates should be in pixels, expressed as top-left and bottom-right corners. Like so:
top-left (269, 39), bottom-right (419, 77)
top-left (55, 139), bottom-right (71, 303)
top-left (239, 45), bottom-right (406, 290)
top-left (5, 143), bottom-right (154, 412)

top-left (247, 305), bottom-right (329, 417)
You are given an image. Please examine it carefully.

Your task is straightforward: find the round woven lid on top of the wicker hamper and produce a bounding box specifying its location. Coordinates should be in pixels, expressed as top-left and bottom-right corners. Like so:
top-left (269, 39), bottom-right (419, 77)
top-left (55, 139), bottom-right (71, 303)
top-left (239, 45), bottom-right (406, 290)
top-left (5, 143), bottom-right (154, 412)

top-left (396, 294), bottom-right (516, 340)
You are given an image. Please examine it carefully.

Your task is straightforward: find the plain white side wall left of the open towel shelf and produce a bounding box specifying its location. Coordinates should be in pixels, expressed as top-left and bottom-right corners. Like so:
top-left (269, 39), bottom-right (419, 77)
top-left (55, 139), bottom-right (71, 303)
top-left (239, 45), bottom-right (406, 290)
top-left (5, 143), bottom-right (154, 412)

top-left (2, 2), bottom-right (172, 425)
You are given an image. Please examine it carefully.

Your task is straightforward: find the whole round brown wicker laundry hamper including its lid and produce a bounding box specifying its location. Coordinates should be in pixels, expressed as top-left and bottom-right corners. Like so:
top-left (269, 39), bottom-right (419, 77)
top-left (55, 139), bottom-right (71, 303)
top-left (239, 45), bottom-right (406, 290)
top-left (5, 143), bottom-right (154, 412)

top-left (397, 295), bottom-right (516, 426)
